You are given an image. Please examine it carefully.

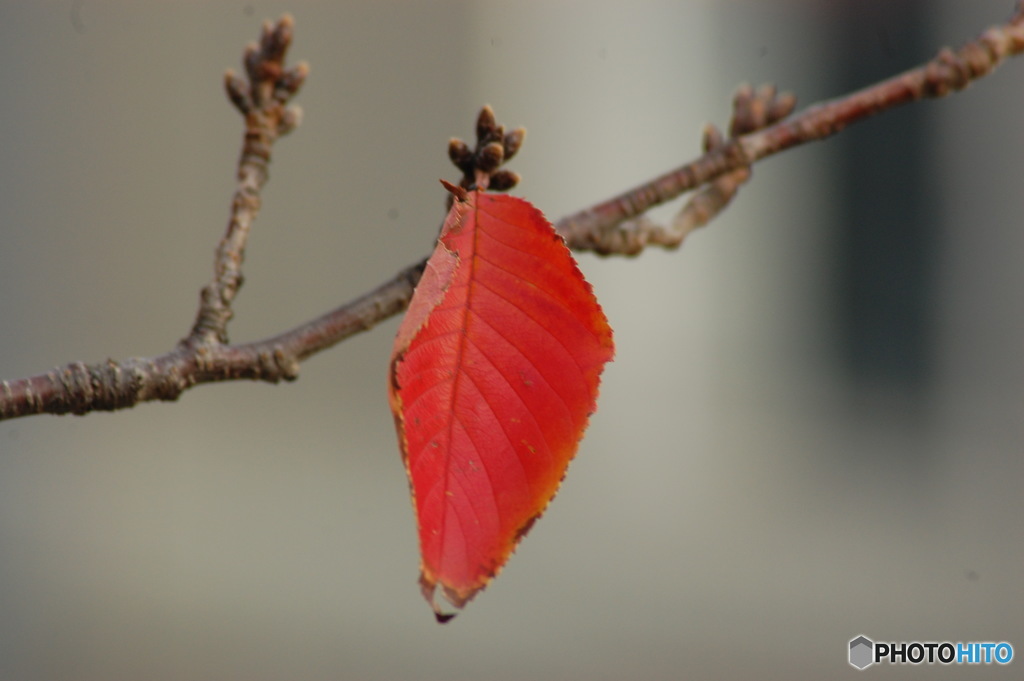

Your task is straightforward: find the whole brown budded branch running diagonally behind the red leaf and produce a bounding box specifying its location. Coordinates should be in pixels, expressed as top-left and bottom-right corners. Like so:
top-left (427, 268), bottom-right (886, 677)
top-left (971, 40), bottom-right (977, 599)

top-left (0, 5), bottom-right (1024, 420)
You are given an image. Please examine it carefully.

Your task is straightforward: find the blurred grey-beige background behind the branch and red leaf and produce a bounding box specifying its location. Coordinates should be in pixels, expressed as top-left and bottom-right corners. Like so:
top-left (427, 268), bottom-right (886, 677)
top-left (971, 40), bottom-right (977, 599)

top-left (0, 0), bottom-right (1024, 680)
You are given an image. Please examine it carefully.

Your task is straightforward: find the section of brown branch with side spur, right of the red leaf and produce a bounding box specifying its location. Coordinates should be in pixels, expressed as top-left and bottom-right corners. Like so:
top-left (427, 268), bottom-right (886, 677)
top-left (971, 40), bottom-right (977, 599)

top-left (556, 8), bottom-right (1024, 255)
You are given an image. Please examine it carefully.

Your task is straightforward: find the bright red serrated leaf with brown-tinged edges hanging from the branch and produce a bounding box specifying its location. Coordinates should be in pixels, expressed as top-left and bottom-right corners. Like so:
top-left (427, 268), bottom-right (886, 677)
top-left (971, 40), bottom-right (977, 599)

top-left (388, 187), bottom-right (612, 622)
